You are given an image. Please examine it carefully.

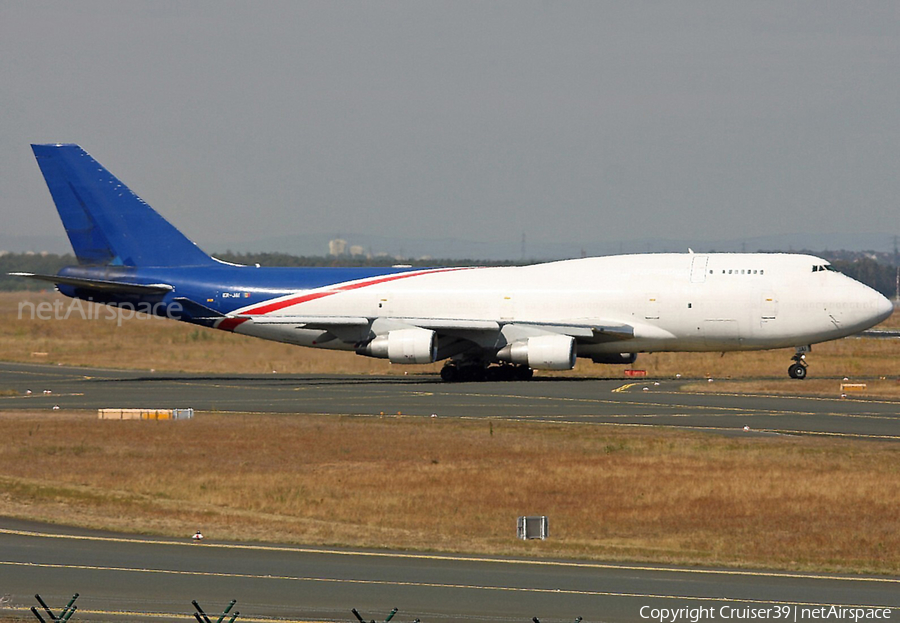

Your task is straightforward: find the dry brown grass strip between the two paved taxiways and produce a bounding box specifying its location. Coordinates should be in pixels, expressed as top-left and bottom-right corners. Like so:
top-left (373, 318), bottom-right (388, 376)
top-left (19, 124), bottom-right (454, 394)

top-left (0, 412), bottom-right (900, 574)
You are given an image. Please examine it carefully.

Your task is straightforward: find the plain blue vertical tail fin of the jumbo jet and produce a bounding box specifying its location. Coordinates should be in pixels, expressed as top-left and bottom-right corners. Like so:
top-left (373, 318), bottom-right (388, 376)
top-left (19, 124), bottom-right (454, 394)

top-left (31, 145), bottom-right (215, 266)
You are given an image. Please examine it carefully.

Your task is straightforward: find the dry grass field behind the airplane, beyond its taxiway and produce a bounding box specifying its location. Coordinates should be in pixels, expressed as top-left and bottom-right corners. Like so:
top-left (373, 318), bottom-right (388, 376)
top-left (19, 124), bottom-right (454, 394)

top-left (0, 292), bottom-right (900, 386)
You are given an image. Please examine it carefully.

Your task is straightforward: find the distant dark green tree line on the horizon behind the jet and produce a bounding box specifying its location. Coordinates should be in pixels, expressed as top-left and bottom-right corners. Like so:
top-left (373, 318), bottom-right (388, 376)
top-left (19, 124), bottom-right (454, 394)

top-left (0, 251), bottom-right (898, 298)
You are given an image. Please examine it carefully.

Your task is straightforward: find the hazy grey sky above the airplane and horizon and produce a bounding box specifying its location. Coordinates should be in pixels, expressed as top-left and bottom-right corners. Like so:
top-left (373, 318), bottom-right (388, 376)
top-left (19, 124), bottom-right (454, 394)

top-left (0, 0), bottom-right (900, 250)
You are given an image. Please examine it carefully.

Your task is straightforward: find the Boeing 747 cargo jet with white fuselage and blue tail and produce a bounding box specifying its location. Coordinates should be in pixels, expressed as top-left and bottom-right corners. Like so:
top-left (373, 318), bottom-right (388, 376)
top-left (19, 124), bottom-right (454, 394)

top-left (19, 144), bottom-right (893, 381)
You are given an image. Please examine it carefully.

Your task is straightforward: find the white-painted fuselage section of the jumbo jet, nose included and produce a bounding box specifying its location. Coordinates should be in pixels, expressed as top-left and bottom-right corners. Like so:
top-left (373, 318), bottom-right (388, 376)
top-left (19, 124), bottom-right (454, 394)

top-left (230, 253), bottom-right (893, 357)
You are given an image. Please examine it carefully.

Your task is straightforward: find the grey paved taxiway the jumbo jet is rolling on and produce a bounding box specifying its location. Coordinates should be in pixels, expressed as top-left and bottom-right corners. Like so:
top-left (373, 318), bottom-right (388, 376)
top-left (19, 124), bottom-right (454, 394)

top-left (0, 363), bottom-right (900, 440)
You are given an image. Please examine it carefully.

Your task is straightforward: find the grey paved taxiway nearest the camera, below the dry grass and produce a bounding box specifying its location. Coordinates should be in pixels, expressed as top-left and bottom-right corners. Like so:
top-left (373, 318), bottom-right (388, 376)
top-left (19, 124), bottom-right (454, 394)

top-left (0, 520), bottom-right (900, 623)
